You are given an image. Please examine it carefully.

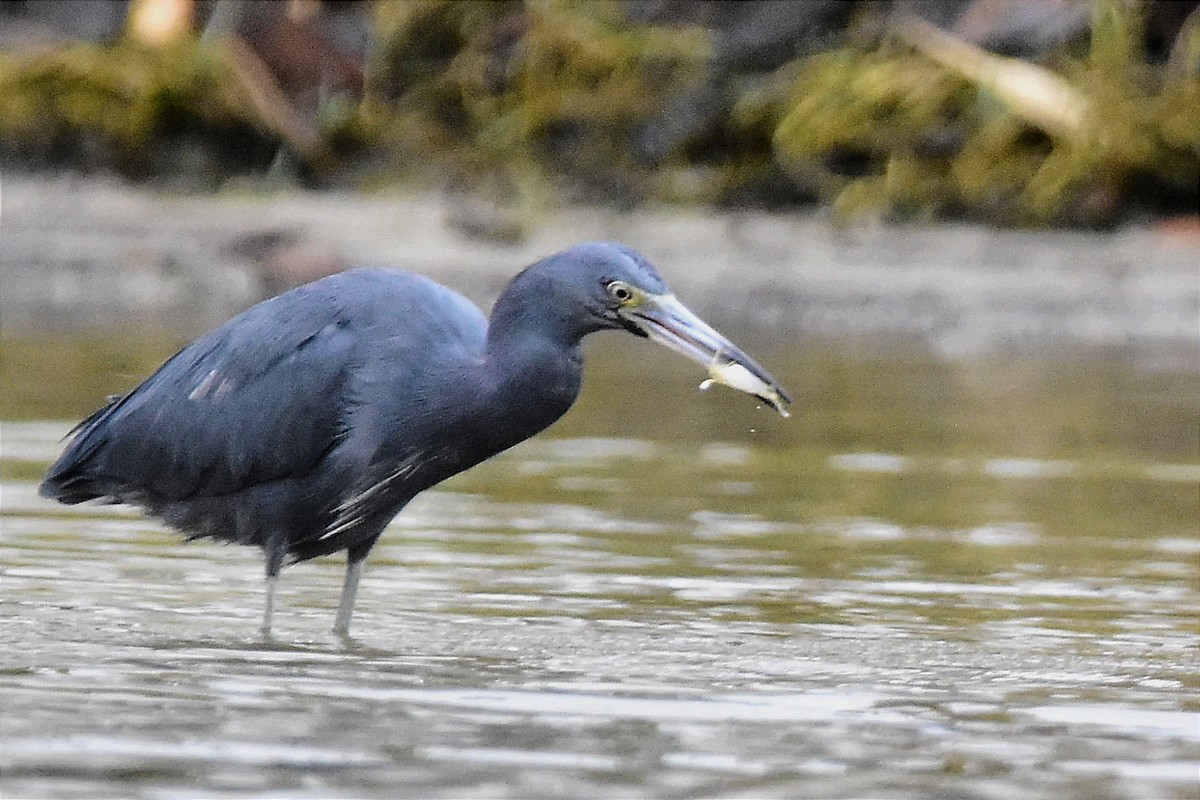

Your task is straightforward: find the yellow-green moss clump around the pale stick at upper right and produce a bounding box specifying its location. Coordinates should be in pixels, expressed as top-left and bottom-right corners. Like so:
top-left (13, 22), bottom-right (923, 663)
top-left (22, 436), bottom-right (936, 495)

top-left (774, 2), bottom-right (1200, 224)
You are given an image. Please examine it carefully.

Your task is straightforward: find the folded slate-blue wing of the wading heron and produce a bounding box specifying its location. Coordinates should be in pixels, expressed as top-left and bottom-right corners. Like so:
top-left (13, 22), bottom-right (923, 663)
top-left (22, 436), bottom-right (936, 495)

top-left (47, 270), bottom-right (486, 500)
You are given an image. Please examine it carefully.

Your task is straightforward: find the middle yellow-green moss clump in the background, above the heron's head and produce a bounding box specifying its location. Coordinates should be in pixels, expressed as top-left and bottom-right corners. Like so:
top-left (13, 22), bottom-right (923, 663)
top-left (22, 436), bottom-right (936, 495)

top-left (372, 0), bottom-right (708, 203)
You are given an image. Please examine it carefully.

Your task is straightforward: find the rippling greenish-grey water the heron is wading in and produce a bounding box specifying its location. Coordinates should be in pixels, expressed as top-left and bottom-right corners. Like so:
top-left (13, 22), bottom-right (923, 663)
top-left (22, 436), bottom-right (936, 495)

top-left (0, 338), bottom-right (1200, 799)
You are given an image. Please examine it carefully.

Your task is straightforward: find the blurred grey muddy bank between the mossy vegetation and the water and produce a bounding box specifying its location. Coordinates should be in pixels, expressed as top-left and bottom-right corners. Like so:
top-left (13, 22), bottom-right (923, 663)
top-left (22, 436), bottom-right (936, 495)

top-left (0, 175), bottom-right (1200, 355)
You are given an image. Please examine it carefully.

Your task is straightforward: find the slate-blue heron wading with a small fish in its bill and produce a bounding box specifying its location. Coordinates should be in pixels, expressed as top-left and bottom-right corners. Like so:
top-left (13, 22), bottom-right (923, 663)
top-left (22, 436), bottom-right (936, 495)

top-left (40, 242), bottom-right (791, 636)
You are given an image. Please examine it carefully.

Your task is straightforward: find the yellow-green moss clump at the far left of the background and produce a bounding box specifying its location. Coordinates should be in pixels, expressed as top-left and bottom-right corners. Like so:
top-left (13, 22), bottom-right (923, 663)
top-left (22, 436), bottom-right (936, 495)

top-left (0, 41), bottom-right (278, 180)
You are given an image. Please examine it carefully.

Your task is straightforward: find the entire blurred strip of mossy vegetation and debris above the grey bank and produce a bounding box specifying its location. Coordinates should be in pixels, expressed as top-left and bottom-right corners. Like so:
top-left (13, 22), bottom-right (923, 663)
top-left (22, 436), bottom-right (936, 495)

top-left (0, 0), bottom-right (1200, 226)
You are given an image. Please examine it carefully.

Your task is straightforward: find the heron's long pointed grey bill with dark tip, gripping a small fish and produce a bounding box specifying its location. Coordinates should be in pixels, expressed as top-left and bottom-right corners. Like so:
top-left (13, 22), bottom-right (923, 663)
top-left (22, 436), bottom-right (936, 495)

top-left (619, 294), bottom-right (792, 416)
